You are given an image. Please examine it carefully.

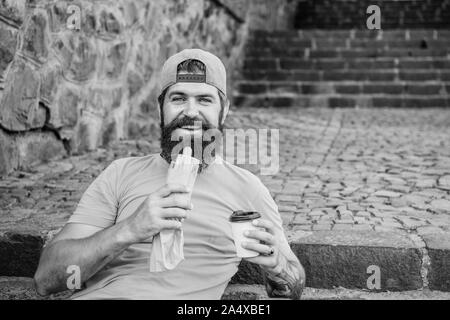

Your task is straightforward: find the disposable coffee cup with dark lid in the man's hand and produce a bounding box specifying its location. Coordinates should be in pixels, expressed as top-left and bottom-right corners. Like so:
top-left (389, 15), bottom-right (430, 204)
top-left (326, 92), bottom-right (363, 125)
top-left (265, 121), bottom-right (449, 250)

top-left (230, 210), bottom-right (261, 258)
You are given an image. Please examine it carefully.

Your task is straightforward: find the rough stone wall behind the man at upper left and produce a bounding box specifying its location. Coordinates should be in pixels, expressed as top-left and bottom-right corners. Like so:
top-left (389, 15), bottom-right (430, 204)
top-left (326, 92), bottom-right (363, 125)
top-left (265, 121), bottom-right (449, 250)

top-left (0, 0), bottom-right (248, 174)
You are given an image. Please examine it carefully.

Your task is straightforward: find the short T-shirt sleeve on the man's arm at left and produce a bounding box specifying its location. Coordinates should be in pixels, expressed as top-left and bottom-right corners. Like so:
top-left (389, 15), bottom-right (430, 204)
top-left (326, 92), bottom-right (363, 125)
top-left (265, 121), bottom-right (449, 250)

top-left (67, 162), bottom-right (118, 228)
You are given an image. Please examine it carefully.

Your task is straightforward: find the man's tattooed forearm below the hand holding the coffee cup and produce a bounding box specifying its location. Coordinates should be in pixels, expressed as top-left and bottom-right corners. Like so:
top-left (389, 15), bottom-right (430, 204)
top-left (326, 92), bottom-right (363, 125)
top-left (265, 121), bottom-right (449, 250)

top-left (265, 254), bottom-right (305, 300)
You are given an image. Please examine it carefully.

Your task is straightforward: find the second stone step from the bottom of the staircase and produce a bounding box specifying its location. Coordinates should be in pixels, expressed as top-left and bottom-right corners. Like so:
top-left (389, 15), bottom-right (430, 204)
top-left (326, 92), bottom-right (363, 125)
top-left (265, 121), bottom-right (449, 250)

top-left (234, 81), bottom-right (450, 96)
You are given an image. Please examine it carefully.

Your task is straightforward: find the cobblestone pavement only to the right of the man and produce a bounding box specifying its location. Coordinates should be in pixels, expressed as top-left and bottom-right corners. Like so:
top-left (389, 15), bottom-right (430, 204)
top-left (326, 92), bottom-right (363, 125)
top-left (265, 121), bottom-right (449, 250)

top-left (255, 109), bottom-right (450, 238)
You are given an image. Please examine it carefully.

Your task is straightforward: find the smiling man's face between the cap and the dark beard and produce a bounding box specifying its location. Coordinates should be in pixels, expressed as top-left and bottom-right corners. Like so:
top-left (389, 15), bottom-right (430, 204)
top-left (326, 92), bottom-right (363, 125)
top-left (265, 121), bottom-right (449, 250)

top-left (161, 83), bottom-right (222, 137)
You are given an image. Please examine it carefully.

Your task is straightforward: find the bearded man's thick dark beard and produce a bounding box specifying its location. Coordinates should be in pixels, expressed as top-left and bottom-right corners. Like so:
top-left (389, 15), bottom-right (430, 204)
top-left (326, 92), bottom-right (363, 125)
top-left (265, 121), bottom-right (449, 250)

top-left (161, 116), bottom-right (223, 173)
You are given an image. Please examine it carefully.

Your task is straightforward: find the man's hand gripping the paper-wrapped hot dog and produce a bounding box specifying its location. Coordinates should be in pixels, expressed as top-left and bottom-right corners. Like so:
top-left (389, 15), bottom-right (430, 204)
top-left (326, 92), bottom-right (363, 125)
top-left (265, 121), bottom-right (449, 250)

top-left (124, 185), bottom-right (192, 243)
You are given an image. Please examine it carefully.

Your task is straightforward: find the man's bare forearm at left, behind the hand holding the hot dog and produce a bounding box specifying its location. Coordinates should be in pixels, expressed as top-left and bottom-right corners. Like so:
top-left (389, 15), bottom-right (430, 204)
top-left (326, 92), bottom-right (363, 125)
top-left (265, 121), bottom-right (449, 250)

top-left (34, 221), bottom-right (133, 295)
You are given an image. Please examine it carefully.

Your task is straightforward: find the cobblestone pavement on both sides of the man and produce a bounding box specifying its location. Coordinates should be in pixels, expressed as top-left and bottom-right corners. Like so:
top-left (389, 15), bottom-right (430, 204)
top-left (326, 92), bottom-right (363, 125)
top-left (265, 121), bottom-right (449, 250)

top-left (0, 108), bottom-right (450, 240)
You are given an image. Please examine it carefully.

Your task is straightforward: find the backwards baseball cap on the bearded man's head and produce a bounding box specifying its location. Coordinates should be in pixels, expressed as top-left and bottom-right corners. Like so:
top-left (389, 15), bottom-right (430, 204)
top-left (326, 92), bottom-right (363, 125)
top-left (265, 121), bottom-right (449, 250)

top-left (160, 49), bottom-right (227, 95)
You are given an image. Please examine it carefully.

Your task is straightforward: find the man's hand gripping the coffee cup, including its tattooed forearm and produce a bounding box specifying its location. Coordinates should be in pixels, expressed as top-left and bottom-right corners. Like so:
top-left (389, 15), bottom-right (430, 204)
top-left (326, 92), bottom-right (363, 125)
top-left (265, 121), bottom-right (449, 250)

top-left (242, 219), bottom-right (305, 300)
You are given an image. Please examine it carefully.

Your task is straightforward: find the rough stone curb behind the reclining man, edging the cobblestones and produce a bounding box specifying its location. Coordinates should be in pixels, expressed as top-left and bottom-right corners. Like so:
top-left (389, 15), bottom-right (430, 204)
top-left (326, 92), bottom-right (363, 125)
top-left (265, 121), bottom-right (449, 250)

top-left (0, 231), bottom-right (450, 292)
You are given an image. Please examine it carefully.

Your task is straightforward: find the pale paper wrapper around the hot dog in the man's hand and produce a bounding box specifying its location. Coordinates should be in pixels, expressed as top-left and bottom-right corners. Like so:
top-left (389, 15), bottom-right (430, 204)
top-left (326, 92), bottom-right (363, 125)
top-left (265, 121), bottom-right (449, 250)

top-left (150, 147), bottom-right (200, 272)
